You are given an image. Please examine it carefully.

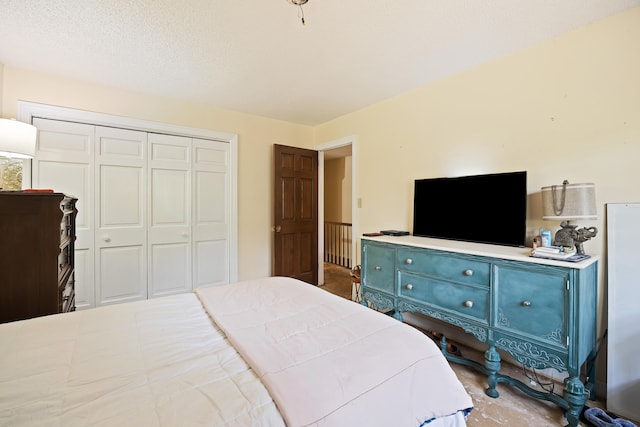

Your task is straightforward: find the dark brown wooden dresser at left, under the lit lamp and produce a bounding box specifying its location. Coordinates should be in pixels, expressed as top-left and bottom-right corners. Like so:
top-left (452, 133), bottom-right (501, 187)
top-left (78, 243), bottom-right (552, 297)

top-left (0, 191), bottom-right (77, 323)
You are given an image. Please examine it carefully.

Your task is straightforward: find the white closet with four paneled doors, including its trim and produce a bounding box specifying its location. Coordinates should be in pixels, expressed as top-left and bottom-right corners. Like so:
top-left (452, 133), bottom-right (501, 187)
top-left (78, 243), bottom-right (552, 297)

top-left (23, 106), bottom-right (237, 309)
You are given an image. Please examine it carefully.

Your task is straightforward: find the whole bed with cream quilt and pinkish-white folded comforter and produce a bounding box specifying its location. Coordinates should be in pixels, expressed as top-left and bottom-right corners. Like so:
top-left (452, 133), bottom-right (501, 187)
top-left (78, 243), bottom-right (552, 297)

top-left (0, 277), bottom-right (472, 427)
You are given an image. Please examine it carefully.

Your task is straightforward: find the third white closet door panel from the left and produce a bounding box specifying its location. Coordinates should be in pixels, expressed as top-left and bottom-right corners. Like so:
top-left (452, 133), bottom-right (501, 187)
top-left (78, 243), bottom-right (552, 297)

top-left (148, 134), bottom-right (192, 297)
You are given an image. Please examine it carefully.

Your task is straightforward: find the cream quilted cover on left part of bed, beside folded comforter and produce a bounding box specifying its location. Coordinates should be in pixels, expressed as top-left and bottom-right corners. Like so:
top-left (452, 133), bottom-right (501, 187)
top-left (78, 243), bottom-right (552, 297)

top-left (0, 294), bottom-right (284, 427)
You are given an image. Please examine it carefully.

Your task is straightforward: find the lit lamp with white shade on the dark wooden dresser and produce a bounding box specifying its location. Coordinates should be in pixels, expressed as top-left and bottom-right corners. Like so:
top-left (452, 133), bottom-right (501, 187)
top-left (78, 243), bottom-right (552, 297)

top-left (0, 119), bottom-right (38, 190)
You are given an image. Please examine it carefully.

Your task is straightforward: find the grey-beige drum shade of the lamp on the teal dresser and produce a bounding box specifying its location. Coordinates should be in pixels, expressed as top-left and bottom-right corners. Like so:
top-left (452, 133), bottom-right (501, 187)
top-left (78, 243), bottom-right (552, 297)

top-left (542, 181), bottom-right (598, 220)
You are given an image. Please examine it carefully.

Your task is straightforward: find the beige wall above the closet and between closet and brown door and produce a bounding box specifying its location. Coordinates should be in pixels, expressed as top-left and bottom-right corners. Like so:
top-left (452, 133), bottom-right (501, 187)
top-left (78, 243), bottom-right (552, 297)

top-left (0, 66), bottom-right (313, 280)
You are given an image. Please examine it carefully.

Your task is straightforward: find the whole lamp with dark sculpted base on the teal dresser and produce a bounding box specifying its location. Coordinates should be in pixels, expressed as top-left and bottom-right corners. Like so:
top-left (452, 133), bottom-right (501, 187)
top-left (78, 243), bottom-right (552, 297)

top-left (542, 180), bottom-right (598, 254)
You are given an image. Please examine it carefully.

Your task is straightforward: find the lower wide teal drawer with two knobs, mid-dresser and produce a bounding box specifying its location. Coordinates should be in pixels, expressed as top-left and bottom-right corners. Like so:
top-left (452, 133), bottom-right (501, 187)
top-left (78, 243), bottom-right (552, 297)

top-left (399, 271), bottom-right (489, 324)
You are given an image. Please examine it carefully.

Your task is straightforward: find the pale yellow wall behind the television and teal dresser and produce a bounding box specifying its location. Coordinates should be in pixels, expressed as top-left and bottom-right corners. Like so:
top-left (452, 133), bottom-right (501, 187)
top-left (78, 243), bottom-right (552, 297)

top-left (315, 8), bottom-right (640, 394)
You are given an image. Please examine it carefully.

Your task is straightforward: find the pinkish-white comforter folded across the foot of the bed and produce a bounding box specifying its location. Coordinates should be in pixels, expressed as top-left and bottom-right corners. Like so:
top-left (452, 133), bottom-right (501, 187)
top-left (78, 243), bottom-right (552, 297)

top-left (197, 277), bottom-right (472, 427)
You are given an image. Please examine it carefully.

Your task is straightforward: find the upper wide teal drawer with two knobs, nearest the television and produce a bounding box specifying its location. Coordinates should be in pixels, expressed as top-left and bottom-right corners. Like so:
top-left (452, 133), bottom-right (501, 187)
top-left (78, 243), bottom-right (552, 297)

top-left (397, 249), bottom-right (491, 287)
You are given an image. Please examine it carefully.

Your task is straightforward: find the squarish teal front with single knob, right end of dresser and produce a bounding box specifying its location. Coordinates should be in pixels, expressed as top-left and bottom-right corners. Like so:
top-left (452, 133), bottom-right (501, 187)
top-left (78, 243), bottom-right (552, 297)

top-left (496, 266), bottom-right (569, 346)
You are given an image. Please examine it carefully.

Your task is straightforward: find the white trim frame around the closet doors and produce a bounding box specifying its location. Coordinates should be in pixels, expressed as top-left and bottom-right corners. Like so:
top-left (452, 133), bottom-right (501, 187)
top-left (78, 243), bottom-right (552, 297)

top-left (17, 101), bottom-right (238, 283)
